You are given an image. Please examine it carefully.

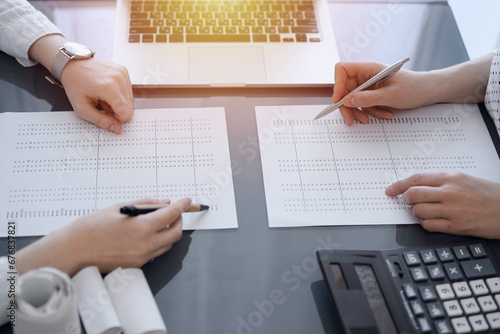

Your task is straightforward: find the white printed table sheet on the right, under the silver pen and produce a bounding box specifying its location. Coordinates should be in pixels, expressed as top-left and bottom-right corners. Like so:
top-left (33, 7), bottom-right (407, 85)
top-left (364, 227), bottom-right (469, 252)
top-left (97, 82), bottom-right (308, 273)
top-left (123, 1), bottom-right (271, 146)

top-left (256, 104), bottom-right (500, 227)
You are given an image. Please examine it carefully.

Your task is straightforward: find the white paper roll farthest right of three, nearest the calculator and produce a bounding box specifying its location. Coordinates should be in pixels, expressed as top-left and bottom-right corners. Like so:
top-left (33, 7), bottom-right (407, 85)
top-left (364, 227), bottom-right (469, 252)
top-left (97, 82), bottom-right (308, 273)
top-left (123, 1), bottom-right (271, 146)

top-left (104, 268), bottom-right (167, 334)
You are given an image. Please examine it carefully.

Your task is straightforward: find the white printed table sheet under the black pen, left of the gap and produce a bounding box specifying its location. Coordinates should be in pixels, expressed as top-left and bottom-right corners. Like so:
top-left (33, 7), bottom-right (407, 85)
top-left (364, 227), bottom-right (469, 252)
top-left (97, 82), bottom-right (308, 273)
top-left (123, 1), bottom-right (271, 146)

top-left (0, 108), bottom-right (238, 236)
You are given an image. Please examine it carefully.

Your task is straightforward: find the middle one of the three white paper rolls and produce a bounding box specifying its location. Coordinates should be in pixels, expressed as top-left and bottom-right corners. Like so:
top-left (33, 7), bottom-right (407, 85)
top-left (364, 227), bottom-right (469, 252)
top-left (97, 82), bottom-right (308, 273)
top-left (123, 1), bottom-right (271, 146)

top-left (71, 266), bottom-right (122, 334)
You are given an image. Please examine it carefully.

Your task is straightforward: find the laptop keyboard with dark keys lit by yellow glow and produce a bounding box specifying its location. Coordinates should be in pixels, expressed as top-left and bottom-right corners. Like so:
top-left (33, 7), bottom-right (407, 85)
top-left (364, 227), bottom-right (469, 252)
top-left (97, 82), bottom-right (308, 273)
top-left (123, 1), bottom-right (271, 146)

top-left (128, 0), bottom-right (321, 43)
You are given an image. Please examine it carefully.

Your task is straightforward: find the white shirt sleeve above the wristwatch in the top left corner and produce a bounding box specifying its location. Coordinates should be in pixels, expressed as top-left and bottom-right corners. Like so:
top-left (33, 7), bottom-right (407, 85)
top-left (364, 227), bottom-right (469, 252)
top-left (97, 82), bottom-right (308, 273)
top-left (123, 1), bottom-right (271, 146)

top-left (0, 0), bottom-right (62, 66)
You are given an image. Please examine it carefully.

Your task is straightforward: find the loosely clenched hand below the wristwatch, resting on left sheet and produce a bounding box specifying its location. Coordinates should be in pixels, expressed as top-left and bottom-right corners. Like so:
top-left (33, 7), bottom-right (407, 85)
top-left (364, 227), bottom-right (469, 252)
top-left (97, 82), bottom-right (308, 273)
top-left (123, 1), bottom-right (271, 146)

top-left (61, 58), bottom-right (134, 134)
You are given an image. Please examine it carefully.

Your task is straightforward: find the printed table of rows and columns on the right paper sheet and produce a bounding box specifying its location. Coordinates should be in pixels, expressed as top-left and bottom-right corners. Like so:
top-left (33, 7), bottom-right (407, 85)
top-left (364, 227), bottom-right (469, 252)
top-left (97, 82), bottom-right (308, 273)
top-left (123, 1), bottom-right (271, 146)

top-left (273, 117), bottom-right (476, 213)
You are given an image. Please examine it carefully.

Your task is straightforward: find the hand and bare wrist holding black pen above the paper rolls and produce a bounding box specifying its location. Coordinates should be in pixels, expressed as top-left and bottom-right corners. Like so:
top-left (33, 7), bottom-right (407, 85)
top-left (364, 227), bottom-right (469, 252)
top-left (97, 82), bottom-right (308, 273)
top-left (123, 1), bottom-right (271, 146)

top-left (16, 198), bottom-right (191, 276)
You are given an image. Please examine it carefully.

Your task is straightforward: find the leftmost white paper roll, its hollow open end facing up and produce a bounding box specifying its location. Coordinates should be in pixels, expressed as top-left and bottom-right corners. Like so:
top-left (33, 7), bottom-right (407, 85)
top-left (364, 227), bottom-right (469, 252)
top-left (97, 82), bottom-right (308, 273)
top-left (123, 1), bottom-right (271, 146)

top-left (13, 268), bottom-right (81, 334)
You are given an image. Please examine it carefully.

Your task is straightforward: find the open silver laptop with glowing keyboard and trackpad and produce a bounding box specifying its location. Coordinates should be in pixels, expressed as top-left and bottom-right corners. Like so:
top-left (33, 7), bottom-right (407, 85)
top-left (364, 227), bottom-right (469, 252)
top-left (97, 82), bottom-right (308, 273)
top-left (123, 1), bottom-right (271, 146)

top-left (113, 0), bottom-right (339, 87)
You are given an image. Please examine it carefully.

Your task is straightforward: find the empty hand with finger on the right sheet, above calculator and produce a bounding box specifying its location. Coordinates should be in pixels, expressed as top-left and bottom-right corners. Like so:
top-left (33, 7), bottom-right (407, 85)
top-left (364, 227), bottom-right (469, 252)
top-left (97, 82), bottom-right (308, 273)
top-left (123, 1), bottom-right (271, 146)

top-left (386, 173), bottom-right (500, 239)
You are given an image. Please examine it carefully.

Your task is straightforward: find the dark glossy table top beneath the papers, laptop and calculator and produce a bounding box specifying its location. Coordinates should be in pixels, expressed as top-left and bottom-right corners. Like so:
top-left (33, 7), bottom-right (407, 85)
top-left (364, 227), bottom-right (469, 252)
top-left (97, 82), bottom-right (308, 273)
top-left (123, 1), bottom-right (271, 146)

top-left (0, 1), bottom-right (498, 334)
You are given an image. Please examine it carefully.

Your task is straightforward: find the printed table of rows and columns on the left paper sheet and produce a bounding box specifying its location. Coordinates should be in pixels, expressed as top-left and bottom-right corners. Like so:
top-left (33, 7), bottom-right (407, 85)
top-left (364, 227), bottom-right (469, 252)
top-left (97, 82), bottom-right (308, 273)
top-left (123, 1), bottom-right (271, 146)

top-left (7, 118), bottom-right (217, 218)
